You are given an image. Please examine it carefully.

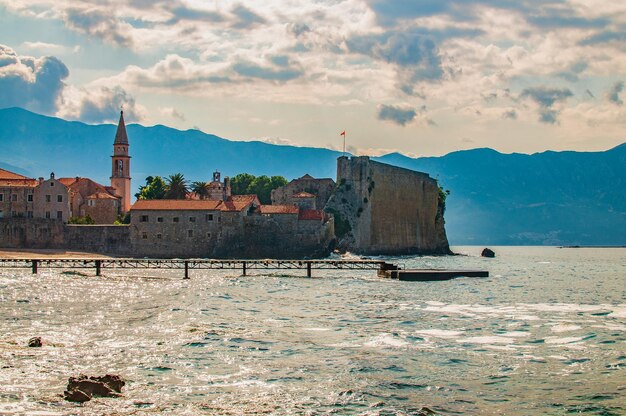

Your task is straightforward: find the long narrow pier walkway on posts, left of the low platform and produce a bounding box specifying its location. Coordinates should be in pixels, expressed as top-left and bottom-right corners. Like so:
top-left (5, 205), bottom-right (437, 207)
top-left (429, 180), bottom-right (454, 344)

top-left (0, 258), bottom-right (398, 279)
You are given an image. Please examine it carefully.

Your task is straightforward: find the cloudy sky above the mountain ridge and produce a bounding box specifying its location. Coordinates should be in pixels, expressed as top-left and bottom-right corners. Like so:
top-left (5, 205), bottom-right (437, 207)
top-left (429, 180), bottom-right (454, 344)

top-left (0, 0), bottom-right (626, 156)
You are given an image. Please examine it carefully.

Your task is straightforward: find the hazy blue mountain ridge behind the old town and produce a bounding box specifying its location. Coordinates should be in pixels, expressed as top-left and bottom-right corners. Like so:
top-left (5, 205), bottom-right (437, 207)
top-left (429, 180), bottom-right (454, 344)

top-left (0, 108), bottom-right (626, 245)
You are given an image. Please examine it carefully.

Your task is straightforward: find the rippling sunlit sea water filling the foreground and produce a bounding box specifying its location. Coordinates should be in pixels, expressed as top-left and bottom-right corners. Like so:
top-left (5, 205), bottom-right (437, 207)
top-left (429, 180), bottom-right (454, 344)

top-left (0, 247), bottom-right (626, 416)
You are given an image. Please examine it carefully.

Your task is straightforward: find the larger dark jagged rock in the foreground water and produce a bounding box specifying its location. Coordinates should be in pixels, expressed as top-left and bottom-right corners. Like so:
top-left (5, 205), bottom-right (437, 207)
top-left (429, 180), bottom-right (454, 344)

top-left (64, 374), bottom-right (126, 403)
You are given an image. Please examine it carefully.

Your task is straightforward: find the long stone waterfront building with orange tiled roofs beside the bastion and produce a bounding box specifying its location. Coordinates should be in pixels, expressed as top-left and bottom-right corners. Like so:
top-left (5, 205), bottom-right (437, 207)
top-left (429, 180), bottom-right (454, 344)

top-left (129, 195), bottom-right (334, 258)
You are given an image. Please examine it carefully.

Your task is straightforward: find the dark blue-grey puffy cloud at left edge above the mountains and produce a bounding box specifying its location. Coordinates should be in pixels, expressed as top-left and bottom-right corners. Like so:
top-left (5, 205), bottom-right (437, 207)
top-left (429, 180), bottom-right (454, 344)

top-left (0, 45), bottom-right (69, 114)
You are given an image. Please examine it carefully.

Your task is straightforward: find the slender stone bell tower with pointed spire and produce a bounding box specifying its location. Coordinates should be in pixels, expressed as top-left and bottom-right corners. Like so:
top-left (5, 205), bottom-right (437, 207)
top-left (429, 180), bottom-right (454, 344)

top-left (111, 111), bottom-right (130, 213)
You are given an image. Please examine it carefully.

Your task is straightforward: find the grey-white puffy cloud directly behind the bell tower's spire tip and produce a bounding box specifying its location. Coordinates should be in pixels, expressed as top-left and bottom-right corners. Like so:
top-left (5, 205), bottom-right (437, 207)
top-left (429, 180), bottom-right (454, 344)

top-left (58, 86), bottom-right (144, 123)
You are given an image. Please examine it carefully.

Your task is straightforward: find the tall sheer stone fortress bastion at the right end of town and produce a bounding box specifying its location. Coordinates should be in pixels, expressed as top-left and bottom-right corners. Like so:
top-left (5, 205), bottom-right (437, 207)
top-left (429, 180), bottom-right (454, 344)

top-left (327, 156), bottom-right (450, 255)
